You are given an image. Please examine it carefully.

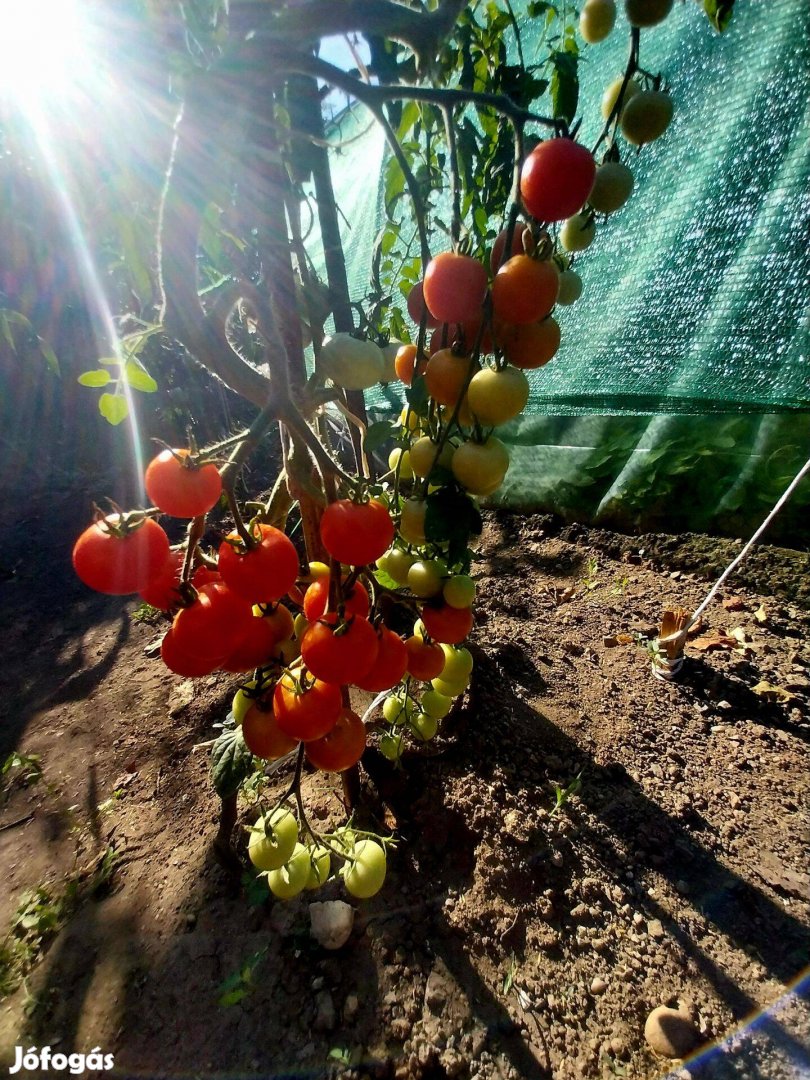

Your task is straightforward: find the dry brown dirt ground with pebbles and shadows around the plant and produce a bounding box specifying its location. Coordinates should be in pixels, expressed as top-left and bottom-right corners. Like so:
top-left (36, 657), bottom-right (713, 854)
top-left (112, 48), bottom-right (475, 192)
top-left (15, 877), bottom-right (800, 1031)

top-left (0, 492), bottom-right (810, 1080)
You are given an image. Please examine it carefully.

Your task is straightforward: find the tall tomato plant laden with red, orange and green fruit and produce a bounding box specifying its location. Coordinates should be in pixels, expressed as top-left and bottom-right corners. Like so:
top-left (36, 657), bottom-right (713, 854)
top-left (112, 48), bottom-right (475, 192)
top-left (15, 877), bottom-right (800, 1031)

top-left (63, 0), bottom-right (719, 899)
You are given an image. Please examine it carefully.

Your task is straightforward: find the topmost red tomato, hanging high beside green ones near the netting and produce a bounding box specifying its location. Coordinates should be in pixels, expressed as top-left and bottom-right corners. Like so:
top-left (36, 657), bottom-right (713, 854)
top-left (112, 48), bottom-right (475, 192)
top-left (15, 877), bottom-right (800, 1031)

top-left (521, 138), bottom-right (596, 221)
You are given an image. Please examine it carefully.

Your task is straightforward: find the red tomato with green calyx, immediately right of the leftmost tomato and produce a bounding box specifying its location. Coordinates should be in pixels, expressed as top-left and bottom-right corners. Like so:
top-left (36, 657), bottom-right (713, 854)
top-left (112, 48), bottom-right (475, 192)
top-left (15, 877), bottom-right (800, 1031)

top-left (219, 525), bottom-right (298, 604)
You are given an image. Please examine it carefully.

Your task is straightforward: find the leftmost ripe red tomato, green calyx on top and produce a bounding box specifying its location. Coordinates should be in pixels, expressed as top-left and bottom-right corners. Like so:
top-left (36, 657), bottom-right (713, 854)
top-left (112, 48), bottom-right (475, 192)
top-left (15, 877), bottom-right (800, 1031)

top-left (73, 514), bottom-right (172, 596)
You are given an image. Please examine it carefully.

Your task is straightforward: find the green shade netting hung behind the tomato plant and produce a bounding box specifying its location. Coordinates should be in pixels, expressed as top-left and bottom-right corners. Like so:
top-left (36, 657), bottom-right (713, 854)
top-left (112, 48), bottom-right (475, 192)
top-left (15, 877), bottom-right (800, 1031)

top-left (313, 0), bottom-right (810, 540)
